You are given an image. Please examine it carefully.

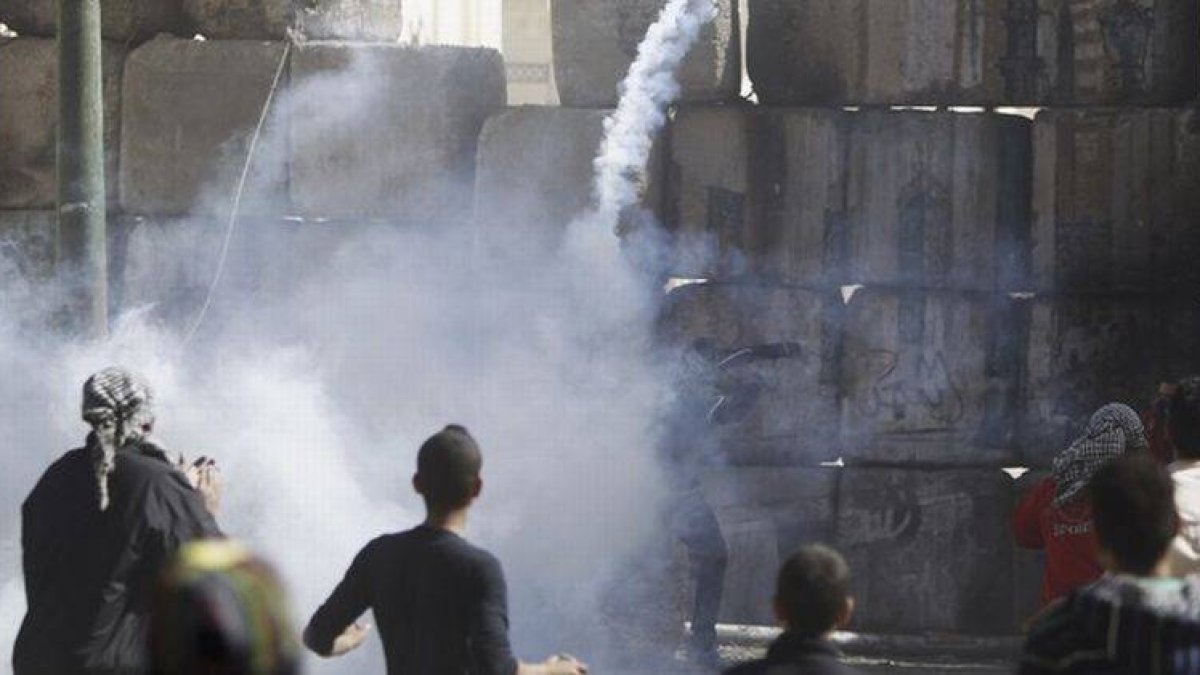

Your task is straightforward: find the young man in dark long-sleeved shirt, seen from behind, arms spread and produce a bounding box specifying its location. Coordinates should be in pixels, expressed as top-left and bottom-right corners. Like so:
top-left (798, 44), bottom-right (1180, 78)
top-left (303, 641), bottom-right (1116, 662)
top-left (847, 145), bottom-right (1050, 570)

top-left (304, 425), bottom-right (587, 675)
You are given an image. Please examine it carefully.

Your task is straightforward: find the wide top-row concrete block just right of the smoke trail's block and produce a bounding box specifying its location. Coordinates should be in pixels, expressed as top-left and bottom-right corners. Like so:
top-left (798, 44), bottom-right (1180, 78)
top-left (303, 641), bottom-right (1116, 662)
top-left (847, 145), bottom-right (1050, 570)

top-left (746, 0), bottom-right (1004, 104)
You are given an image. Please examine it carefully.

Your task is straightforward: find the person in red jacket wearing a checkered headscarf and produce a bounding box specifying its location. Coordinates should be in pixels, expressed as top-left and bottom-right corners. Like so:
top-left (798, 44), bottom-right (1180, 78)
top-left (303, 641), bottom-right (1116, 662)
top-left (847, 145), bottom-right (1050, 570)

top-left (1013, 404), bottom-right (1146, 607)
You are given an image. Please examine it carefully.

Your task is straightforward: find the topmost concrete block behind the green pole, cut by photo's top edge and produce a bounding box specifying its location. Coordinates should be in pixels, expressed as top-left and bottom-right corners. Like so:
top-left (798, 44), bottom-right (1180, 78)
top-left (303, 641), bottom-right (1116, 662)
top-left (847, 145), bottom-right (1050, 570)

top-left (0, 0), bottom-right (185, 46)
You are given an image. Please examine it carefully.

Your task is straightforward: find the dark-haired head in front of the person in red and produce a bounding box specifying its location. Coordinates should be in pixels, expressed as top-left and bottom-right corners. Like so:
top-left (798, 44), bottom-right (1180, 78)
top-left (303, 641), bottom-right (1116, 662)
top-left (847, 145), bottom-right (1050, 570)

top-left (1090, 454), bottom-right (1178, 577)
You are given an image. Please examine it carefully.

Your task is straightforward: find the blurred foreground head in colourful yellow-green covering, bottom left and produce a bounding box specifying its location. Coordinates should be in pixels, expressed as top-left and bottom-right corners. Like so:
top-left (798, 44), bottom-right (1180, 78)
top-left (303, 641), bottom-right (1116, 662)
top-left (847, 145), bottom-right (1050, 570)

top-left (148, 540), bottom-right (300, 675)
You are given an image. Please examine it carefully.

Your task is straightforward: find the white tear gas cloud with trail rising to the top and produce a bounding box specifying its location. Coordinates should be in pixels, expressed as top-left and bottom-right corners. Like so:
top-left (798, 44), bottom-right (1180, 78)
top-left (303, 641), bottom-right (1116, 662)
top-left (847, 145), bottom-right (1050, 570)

top-left (0, 0), bottom-right (712, 673)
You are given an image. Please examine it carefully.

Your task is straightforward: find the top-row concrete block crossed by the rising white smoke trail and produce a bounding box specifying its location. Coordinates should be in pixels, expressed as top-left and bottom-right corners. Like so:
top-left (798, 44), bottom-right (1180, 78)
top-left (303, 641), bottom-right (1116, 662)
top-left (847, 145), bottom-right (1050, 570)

top-left (551, 0), bottom-right (742, 108)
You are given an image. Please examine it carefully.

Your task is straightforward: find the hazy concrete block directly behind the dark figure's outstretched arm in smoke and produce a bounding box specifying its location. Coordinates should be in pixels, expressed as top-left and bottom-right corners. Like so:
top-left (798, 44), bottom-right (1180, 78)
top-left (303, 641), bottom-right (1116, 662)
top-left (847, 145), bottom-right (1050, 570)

top-left (662, 283), bottom-right (841, 464)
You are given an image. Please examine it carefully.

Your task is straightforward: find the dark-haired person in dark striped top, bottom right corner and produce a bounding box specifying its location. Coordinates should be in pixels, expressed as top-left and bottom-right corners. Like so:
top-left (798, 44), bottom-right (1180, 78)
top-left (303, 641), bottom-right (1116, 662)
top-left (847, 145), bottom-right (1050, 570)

top-left (1018, 453), bottom-right (1200, 675)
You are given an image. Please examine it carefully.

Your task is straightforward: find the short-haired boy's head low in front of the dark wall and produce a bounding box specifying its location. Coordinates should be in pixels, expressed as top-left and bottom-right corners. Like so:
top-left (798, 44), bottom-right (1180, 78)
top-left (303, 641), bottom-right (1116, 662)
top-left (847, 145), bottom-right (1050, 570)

top-left (775, 544), bottom-right (854, 638)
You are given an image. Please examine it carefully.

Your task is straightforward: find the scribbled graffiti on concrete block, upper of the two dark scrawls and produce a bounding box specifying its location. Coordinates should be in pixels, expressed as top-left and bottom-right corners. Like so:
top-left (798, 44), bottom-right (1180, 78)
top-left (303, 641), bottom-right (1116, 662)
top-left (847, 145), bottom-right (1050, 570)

top-left (857, 350), bottom-right (966, 428)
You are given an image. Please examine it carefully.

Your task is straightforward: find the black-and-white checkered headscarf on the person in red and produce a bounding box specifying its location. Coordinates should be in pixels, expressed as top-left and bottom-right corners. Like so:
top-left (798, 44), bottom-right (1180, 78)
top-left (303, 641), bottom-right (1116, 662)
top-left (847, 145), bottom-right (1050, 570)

top-left (1054, 404), bottom-right (1148, 506)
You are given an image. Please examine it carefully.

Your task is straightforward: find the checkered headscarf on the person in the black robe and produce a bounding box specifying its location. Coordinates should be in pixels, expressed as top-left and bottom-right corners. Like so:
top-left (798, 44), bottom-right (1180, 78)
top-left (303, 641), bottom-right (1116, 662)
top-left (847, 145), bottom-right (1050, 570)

top-left (83, 368), bottom-right (154, 510)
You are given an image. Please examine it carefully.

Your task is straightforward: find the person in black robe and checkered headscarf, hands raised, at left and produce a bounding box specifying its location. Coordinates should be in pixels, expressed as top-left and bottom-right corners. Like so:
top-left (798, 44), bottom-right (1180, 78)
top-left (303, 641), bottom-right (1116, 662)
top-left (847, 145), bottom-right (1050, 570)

top-left (13, 369), bottom-right (221, 675)
